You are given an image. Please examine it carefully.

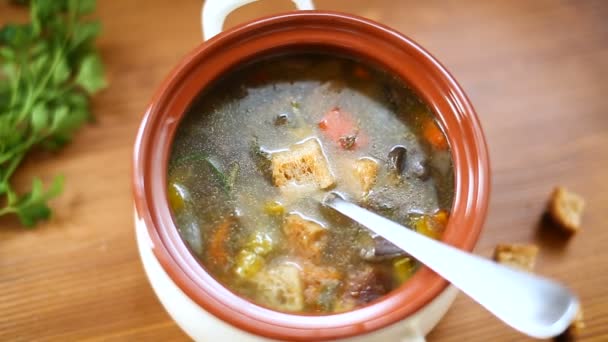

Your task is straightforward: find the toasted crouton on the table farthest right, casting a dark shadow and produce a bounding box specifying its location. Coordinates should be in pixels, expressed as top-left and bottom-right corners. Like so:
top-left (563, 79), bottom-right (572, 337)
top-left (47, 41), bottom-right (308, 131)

top-left (547, 186), bottom-right (585, 233)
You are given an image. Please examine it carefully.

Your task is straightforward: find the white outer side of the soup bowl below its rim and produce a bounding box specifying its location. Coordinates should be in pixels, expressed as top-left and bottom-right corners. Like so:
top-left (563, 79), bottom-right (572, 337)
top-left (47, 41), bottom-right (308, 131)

top-left (135, 213), bottom-right (458, 342)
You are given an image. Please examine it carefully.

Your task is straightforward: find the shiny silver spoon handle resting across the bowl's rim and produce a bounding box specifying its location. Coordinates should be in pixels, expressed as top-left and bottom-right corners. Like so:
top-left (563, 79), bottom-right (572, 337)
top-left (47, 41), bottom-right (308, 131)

top-left (324, 196), bottom-right (579, 338)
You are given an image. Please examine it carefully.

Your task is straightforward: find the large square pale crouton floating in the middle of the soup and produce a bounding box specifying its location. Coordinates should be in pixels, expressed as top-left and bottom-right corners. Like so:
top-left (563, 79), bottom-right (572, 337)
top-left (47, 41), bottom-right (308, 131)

top-left (271, 138), bottom-right (335, 189)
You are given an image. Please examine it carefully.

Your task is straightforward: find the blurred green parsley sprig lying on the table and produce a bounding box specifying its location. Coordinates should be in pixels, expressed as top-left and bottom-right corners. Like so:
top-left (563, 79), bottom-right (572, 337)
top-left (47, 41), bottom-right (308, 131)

top-left (0, 0), bottom-right (106, 227)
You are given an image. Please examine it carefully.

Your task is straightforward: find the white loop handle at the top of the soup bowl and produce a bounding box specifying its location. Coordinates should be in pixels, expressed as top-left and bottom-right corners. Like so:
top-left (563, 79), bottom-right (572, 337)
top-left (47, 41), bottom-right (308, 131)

top-left (201, 0), bottom-right (315, 40)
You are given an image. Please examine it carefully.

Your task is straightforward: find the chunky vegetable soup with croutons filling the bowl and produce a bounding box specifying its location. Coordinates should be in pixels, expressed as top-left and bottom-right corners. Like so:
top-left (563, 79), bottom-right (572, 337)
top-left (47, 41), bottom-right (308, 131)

top-left (167, 54), bottom-right (454, 314)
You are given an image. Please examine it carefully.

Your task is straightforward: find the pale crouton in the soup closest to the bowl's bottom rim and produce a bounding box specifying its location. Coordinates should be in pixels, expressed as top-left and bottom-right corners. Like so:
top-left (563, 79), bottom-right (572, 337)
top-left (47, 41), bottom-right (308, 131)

top-left (254, 264), bottom-right (304, 311)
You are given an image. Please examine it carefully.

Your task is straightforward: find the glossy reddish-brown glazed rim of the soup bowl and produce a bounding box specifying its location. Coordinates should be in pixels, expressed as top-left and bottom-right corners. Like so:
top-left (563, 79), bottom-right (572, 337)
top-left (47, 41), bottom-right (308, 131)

top-left (133, 11), bottom-right (490, 340)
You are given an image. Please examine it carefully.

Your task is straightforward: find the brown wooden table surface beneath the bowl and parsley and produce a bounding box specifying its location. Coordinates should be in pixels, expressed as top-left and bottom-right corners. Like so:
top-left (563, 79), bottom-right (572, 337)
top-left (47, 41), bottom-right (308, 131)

top-left (0, 0), bottom-right (608, 341)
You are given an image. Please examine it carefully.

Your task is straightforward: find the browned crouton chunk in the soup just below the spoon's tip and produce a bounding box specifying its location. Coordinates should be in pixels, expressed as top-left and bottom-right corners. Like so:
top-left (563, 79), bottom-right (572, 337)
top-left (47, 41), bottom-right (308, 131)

top-left (283, 213), bottom-right (327, 262)
